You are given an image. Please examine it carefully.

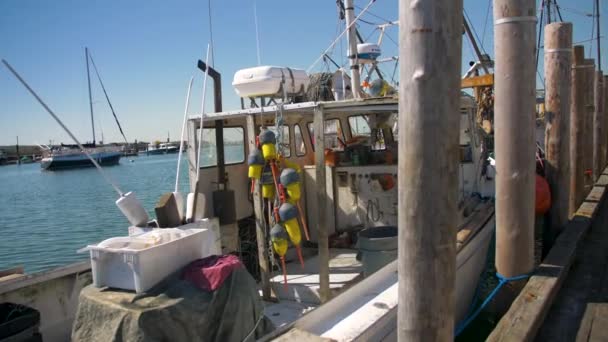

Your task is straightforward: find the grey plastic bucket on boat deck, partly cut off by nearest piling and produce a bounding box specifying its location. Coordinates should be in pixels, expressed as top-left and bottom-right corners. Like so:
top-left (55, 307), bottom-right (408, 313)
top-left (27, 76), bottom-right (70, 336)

top-left (357, 226), bottom-right (398, 277)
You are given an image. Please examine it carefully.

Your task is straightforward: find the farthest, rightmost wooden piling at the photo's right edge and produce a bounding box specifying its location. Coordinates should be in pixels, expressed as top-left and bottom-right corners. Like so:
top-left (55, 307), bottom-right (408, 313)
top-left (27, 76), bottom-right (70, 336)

top-left (593, 71), bottom-right (606, 182)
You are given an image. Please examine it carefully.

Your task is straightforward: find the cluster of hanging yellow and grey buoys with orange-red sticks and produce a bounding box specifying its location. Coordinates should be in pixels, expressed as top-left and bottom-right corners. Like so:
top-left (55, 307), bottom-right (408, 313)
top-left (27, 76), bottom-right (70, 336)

top-left (247, 129), bottom-right (310, 284)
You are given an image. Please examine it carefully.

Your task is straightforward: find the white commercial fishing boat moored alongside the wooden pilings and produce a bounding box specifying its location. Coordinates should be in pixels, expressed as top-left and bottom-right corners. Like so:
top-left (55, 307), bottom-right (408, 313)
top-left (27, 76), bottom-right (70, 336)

top-left (0, 6), bottom-right (495, 341)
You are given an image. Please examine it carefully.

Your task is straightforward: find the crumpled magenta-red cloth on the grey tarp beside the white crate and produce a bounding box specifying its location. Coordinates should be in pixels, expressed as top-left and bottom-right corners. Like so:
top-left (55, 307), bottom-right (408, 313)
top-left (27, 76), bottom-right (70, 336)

top-left (182, 255), bottom-right (243, 291)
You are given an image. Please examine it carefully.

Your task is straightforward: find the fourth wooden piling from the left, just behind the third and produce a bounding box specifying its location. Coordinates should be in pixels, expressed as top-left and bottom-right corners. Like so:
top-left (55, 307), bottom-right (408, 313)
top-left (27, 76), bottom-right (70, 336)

top-left (568, 45), bottom-right (586, 217)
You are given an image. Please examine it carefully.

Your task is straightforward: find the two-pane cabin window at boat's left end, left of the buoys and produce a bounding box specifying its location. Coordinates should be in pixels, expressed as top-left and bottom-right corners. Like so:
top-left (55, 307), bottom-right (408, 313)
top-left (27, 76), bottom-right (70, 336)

top-left (196, 127), bottom-right (245, 167)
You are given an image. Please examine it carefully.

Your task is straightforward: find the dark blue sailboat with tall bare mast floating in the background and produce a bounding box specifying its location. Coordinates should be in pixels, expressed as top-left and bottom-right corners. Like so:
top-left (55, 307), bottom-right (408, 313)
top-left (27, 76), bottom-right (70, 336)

top-left (40, 48), bottom-right (122, 170)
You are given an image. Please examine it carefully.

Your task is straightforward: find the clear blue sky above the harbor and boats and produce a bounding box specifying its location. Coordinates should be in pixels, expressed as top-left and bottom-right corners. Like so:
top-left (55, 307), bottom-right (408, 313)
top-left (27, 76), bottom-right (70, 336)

top-left (0, 0), bottom-right (608, 145)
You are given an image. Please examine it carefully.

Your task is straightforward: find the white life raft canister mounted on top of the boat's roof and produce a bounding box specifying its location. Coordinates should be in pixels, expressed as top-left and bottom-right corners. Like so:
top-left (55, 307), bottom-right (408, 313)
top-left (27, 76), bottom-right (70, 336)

top-left (232, 66), bottom-right (310, 97)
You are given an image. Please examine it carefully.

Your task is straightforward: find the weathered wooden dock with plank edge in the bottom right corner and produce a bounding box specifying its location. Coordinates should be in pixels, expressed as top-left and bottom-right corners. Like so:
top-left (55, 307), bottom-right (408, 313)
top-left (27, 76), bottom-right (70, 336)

top-left (488, 168), bottom-right (608, 341)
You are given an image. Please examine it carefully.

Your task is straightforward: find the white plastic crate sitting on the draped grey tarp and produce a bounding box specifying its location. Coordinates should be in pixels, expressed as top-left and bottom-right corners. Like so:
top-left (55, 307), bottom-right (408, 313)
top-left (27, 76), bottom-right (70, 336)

top-left (88, 223), bottom-right (221, 293)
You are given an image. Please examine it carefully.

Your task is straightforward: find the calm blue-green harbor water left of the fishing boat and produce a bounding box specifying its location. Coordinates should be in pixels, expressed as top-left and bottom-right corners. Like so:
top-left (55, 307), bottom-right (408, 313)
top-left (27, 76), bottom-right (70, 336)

top-left (0, 153), bottom-right (188, 273)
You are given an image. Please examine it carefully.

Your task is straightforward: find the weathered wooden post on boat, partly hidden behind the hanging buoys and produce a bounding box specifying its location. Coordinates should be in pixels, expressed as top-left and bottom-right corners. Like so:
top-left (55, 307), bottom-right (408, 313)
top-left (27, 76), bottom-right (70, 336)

top-left (246, 115), bottom-right (271, 300)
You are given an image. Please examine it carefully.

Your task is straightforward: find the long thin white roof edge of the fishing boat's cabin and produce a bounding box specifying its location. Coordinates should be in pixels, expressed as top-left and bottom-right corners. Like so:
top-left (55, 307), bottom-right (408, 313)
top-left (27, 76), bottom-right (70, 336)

top-left (188, 93), bottom-right (475, 120)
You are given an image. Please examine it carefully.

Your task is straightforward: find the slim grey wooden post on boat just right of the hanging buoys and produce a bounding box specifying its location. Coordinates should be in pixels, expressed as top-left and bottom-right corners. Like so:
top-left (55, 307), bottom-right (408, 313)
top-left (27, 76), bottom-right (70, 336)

top-left (313, 105), bottom-right (331, 303)
